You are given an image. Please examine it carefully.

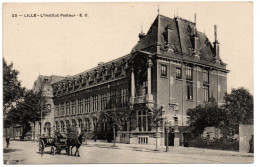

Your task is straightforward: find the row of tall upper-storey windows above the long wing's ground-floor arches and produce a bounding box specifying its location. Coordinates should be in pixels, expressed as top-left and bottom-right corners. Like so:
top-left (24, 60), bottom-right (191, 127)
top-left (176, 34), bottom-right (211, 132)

top-left (55, 89), bottom-right (128, 116)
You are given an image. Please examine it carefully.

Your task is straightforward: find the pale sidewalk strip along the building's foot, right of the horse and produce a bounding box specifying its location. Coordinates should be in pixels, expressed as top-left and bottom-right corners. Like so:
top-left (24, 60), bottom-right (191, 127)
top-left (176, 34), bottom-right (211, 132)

top-left (83, 141), bottom-right (254, 157)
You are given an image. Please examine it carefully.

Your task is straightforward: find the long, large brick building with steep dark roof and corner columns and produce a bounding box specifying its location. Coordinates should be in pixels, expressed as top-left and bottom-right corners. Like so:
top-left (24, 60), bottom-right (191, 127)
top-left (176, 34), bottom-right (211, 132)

top-left (34, 14), bottom-right (228, 145)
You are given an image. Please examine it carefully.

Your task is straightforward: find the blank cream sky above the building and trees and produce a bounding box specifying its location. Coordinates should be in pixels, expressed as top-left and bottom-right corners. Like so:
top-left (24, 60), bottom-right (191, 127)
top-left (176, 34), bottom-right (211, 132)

top-left (3, 2), bottom-right (253, 93)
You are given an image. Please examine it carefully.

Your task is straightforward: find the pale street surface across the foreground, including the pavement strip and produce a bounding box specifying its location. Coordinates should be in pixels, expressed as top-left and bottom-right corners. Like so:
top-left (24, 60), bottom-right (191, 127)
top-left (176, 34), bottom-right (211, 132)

top-left (4, 141), bottom-right (254, 164)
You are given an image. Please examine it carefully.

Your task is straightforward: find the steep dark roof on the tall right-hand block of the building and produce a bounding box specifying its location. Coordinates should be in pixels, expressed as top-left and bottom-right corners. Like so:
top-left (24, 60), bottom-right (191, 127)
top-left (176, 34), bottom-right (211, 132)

top-left (131, 15), bottom-right (224, 65)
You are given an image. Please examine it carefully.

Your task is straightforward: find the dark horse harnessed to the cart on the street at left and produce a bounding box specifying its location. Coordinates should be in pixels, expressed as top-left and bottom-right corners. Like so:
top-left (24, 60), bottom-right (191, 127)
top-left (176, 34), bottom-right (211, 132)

top-left (67, 133), bottom-right (83, 157)
